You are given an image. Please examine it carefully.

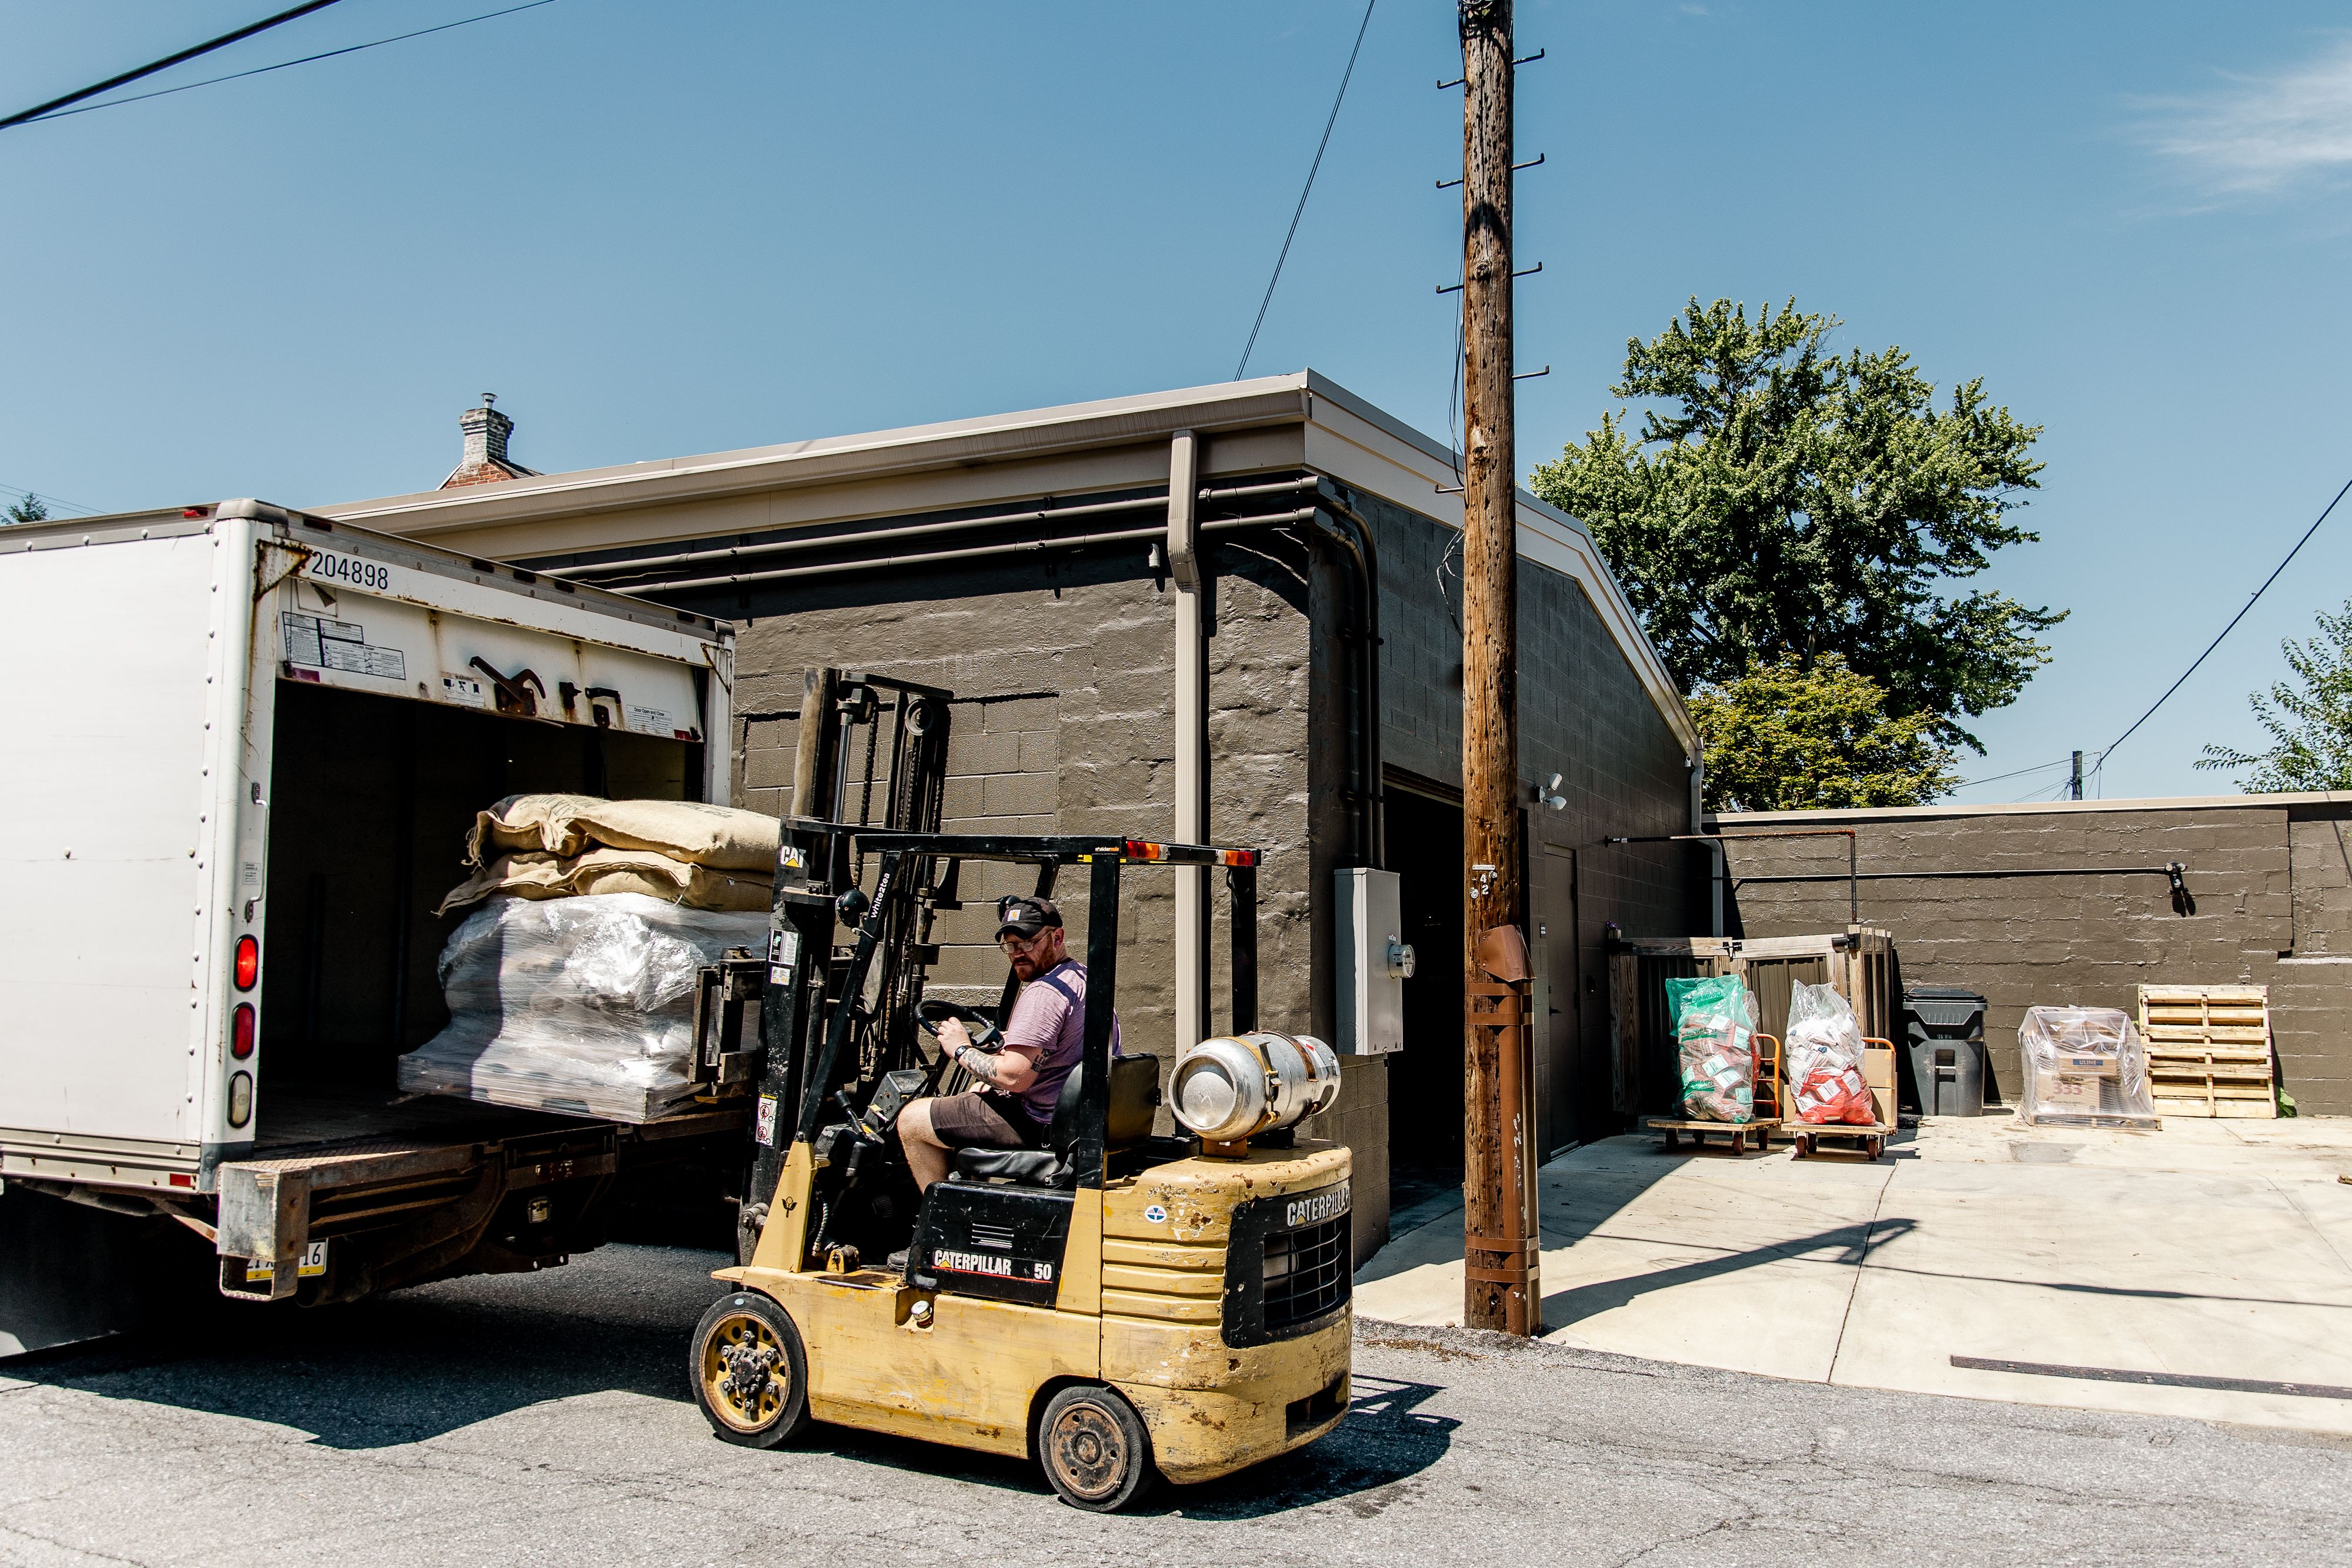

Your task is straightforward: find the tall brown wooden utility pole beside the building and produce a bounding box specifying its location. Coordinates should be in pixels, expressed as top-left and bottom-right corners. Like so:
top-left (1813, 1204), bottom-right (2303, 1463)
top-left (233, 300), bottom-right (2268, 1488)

top-left (1458, 0), bottom-right (1543, 1333)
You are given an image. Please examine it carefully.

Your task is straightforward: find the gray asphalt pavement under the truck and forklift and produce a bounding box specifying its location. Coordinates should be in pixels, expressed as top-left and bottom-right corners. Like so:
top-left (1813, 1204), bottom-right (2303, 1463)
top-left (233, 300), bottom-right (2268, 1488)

top-left (0, 1246), bottom-right (2352, 1568)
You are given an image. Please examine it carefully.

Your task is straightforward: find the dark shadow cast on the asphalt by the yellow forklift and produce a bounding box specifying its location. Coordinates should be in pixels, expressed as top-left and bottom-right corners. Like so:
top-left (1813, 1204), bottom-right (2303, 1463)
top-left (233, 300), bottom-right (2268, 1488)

top-left (793, 1378), bottom-right (1461, 1521)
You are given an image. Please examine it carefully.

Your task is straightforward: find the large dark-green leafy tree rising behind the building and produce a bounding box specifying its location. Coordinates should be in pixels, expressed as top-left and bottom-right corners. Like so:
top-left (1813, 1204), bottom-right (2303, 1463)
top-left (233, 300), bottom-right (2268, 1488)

top-left (1529, 296), bottom-right (2065, 750)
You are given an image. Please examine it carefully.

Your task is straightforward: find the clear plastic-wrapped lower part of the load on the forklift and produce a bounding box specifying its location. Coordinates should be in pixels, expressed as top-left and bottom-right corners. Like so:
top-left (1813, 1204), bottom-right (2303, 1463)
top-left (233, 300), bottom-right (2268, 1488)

top-left (400, 893), bottom-right (767, 1121)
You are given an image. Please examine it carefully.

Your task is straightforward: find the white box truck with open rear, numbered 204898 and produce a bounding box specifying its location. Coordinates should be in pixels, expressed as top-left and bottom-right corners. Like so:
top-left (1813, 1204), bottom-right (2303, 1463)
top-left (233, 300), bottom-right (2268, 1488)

top-left (0, 501), bottom-right (743, 1354)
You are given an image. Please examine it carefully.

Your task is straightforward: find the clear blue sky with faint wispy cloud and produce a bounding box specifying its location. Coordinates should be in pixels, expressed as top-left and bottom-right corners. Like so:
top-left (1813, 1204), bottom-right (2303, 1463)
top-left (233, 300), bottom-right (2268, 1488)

top-left (0, 0), bottom-right (2352, 799)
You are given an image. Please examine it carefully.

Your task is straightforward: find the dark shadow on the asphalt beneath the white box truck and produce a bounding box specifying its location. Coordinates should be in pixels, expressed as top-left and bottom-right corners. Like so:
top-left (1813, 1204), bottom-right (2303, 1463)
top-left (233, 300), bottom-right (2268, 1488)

top-left (5, 1248), bottom-right (724, 1450)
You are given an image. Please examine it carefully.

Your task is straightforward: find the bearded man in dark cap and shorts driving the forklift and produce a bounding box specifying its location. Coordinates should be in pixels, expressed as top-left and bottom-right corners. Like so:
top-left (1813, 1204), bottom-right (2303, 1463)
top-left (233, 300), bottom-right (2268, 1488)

top-left (898, 893), bottom-right (1120, 1192)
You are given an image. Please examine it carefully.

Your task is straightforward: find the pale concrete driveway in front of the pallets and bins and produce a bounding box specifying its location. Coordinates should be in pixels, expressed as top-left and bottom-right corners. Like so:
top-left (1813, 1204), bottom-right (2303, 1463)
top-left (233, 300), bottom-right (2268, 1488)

top-left (1357, 1116), bottom-right (2352, 1434)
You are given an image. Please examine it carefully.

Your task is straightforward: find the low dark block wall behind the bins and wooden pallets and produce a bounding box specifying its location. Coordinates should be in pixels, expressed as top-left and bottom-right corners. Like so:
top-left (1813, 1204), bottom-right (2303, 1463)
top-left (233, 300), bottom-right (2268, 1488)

top-left (1710, 794), bottom-right (2352, 1116)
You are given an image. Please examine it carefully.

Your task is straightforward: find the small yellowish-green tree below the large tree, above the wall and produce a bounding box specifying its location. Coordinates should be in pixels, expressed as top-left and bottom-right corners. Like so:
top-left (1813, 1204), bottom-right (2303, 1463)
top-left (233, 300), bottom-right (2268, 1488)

top-left (1691, 654), bottom-right (1959, 811)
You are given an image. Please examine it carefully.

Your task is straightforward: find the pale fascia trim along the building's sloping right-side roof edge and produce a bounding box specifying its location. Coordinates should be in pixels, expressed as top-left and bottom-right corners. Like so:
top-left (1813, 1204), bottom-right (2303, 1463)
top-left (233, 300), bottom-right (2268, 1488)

top-left (1308, 372), bottom-right (1700, 762)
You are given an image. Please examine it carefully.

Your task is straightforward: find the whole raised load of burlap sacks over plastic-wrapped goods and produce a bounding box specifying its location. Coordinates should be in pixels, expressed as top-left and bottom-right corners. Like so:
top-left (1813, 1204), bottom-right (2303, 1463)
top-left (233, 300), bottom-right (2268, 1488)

top-left (400, 794), bottom-right (776, 1121)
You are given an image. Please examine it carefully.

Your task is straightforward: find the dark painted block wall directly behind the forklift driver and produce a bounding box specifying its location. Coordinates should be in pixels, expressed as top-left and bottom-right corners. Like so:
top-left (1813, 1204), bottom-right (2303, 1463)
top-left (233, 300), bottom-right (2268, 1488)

top-left (680, 536), bottom-right (1388, 1255)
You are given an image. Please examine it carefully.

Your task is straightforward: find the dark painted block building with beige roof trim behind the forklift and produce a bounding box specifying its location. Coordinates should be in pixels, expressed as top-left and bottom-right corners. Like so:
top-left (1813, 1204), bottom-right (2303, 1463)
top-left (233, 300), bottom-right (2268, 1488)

top-left (320, 372), bottom-right (1705, 1255)
